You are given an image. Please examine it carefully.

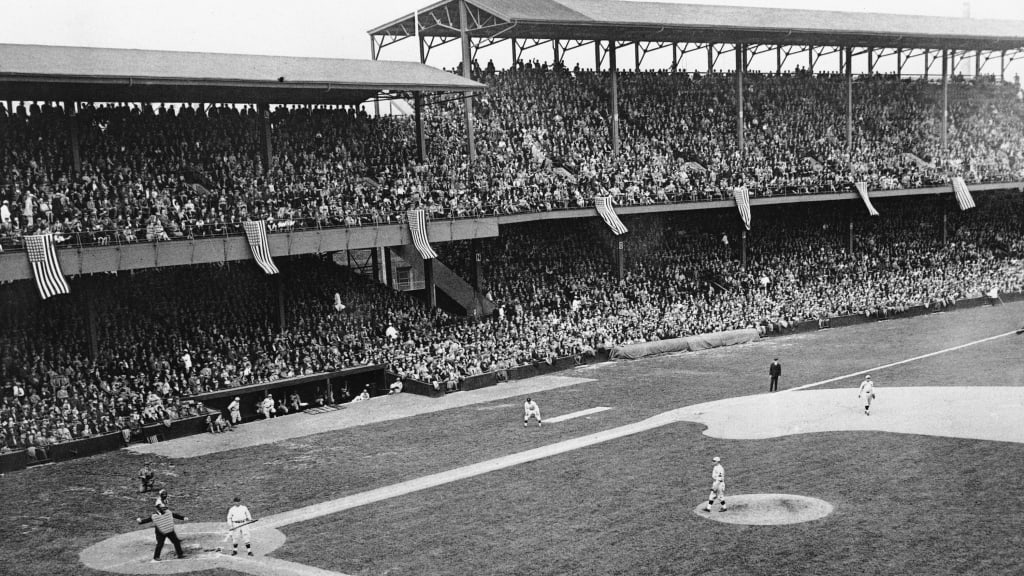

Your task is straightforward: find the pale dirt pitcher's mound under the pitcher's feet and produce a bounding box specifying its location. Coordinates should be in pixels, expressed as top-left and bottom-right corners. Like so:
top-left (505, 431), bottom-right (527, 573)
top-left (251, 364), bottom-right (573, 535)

top-left (693, 494), bottom-right (833, 526)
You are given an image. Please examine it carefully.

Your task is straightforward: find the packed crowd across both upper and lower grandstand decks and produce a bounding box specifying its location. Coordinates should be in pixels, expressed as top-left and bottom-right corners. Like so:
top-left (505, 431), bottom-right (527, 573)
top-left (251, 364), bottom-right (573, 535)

top-left (0, 61), bottom-right (1024, 451)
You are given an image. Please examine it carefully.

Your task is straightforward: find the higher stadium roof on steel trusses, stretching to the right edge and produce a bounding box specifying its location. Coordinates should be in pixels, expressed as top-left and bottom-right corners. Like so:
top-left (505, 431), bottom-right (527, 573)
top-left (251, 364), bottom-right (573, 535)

top-left (370, 0), bottom-right (1024, 50)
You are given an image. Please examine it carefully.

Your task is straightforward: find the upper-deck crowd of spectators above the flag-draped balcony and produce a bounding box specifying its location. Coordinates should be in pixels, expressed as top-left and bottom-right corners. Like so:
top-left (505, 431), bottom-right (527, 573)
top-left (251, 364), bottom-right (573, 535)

top-left (0, 63), bottom-right (1024, 248)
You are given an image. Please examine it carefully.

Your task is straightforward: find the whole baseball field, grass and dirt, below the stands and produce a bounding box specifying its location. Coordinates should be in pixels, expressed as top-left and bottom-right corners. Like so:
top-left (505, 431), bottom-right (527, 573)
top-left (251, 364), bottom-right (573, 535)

top-left (0, 303), bottom-right (1024, 576)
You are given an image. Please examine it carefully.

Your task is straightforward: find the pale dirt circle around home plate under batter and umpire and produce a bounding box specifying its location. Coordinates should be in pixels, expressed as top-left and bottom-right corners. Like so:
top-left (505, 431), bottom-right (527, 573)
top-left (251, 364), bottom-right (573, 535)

top-left (79, 522), bottom-right (285, 574)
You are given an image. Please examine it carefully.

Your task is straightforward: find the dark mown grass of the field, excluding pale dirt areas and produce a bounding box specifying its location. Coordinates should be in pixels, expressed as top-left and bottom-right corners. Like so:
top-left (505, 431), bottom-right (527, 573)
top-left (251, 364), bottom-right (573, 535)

top-left (0, 303), bottom-right (1024, 576)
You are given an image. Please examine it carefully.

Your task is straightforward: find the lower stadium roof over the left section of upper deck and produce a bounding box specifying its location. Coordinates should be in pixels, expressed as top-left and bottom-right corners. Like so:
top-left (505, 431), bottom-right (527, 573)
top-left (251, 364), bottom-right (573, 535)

top-left (0, 44), bottom-right (484, 105)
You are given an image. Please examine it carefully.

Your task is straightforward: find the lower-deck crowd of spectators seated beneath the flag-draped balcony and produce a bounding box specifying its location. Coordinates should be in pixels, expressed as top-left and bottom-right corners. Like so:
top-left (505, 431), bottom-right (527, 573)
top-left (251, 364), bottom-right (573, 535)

top-left (0, 195), bottom-right (1024, 451)
